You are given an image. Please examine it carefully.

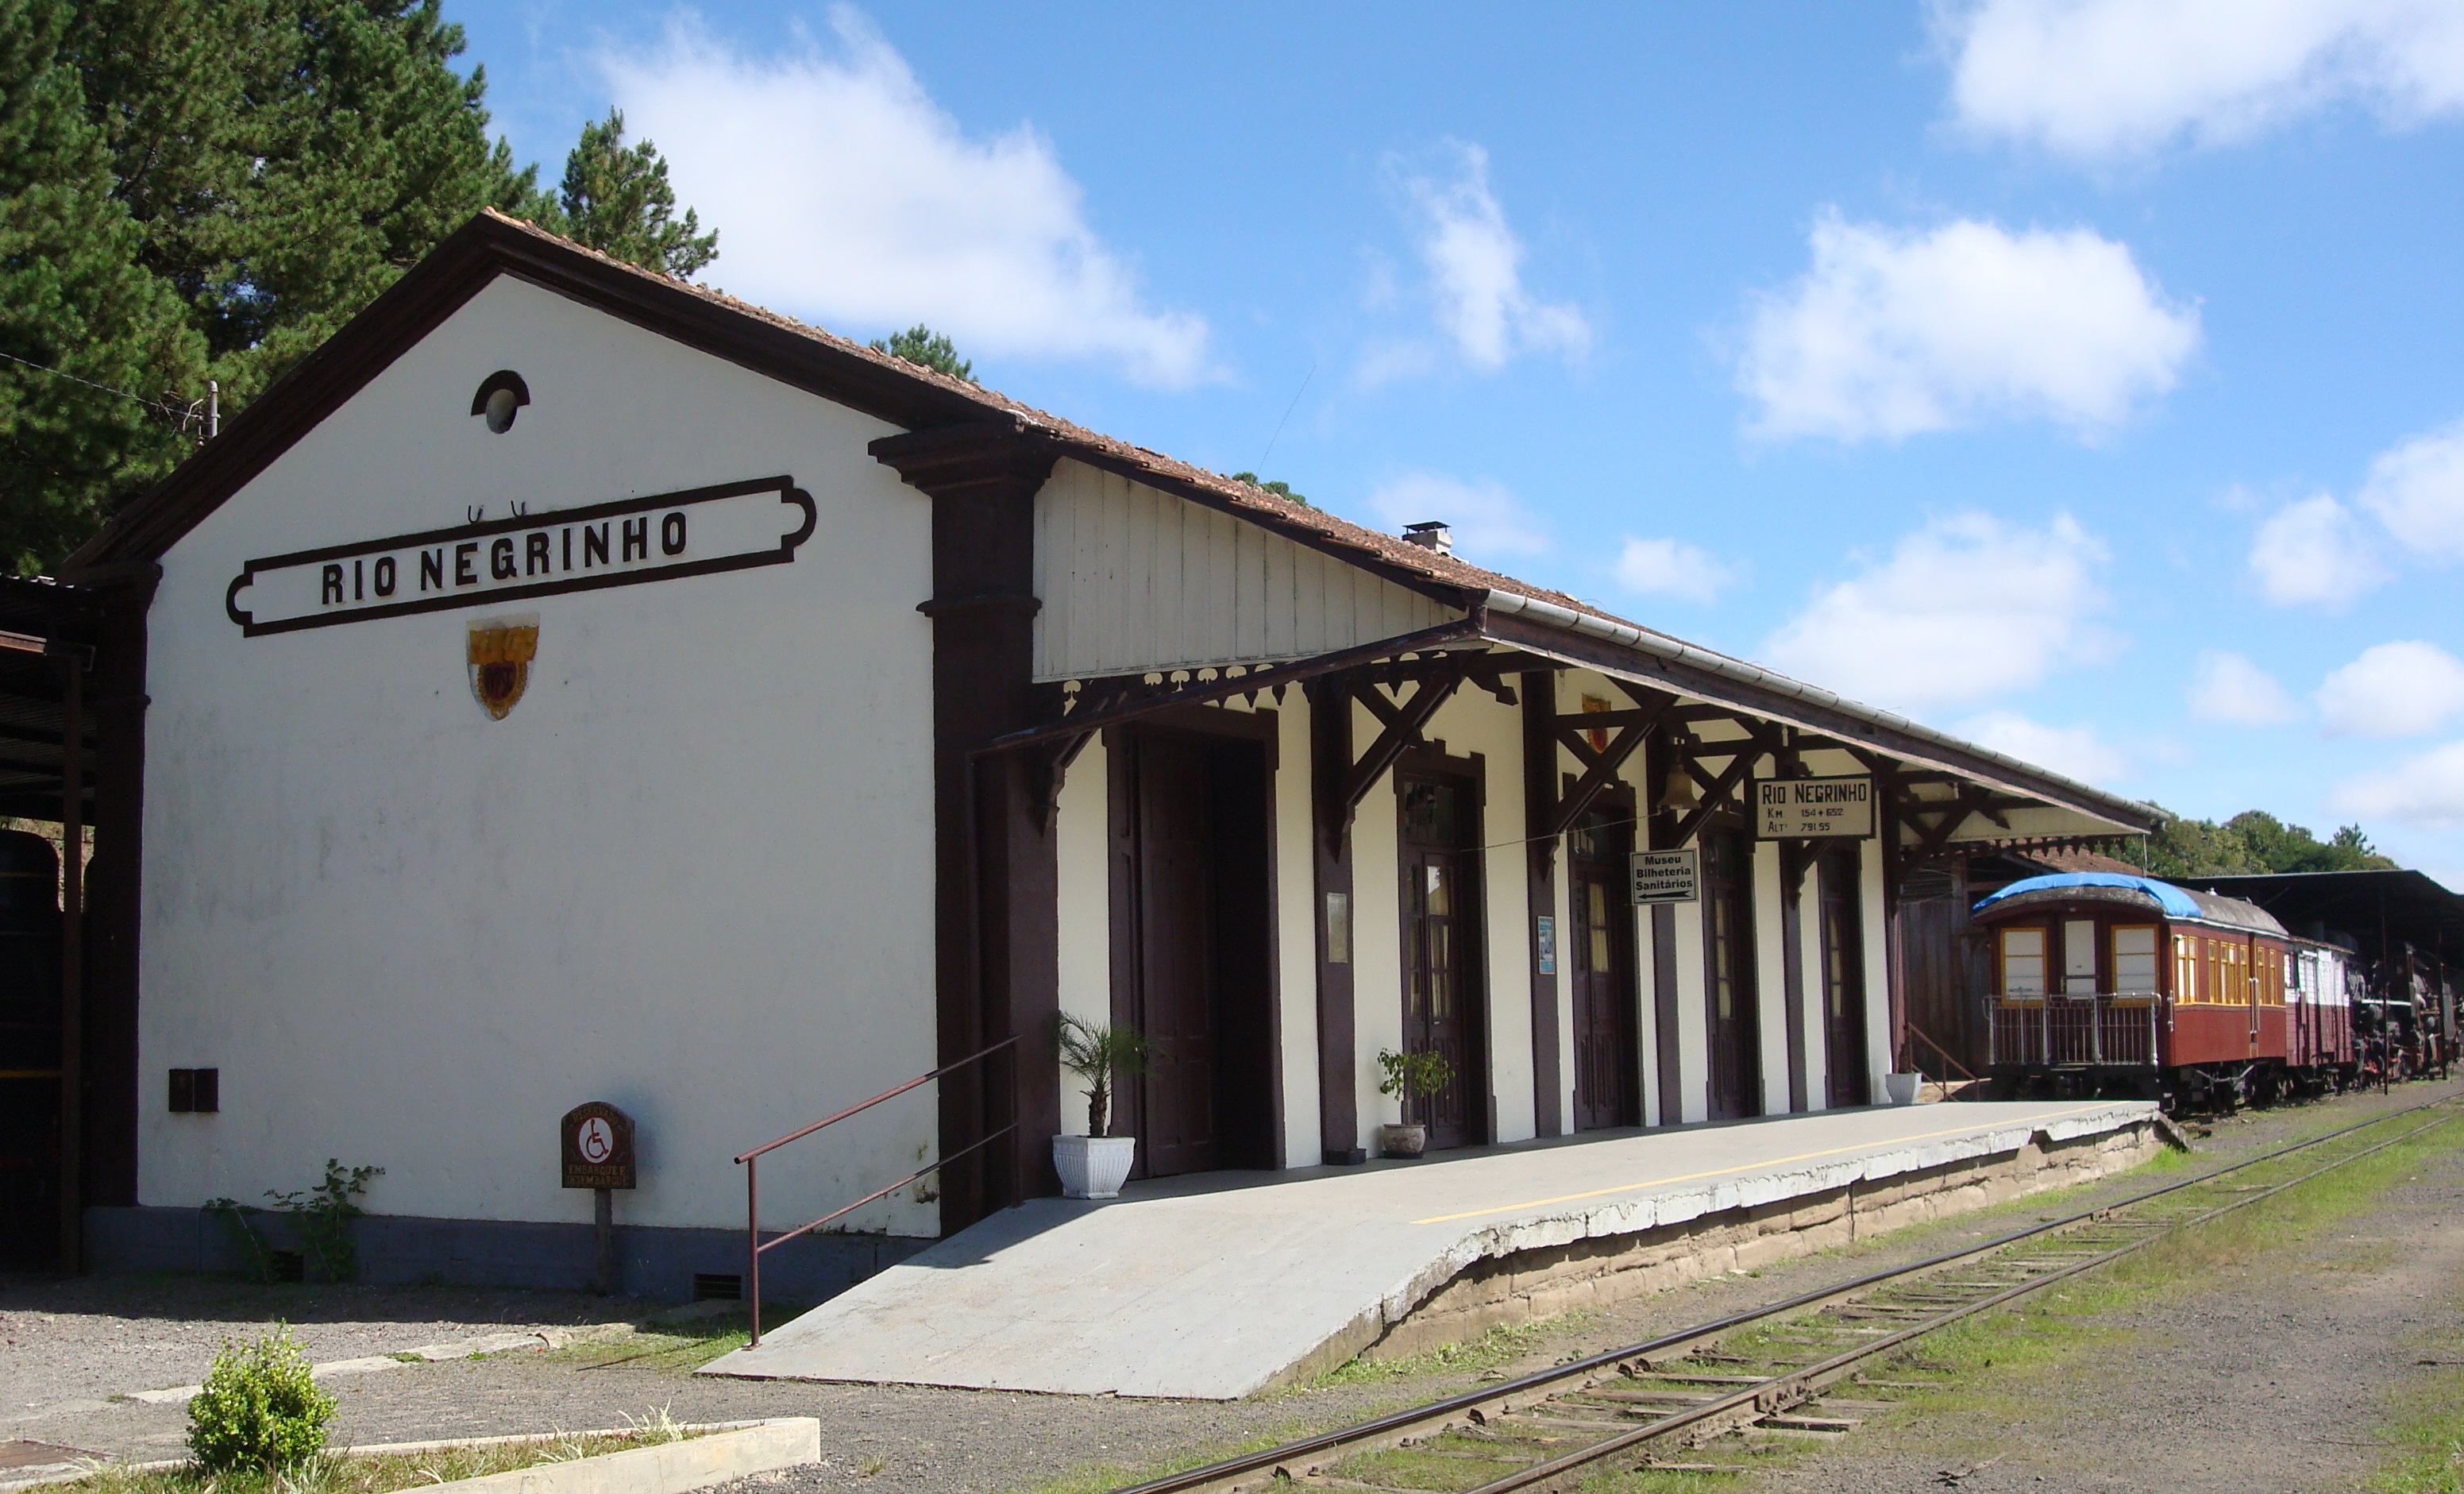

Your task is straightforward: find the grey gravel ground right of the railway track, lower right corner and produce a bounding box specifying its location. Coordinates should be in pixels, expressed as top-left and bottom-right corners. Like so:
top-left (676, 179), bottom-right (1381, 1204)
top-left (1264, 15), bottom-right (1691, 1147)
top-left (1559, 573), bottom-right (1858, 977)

top-left (1764, 1089), bottom-right (2464, 1494)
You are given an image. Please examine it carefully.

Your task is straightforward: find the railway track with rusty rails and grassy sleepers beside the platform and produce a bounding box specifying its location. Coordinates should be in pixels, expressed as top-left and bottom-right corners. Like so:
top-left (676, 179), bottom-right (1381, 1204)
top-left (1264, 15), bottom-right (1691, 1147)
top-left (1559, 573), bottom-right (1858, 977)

top-left (1114, 1099), bottom-right (2464, 1494)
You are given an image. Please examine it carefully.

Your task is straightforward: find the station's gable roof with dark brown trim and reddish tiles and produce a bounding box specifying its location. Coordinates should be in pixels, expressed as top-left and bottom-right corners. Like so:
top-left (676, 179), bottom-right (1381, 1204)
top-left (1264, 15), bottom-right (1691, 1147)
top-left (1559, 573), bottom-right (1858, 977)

top-left (62, 210), bottom-right (2158, 831)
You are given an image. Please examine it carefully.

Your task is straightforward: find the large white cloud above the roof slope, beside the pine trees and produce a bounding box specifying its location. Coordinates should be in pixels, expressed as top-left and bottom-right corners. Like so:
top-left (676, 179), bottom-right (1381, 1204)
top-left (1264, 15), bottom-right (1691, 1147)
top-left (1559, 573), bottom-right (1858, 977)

top-left (601, 7), bottom-right (1210, 387)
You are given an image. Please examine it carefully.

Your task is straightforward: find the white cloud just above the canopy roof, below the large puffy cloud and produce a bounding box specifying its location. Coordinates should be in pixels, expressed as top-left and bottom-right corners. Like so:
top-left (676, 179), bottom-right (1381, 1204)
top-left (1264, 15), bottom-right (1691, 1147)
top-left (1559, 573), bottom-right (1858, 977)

top-left (1764, 513), bottom-right (2116, 710)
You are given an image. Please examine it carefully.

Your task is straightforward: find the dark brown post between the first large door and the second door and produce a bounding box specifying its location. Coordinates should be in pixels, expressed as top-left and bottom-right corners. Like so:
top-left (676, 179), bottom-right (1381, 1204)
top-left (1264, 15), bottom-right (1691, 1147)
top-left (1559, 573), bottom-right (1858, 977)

top-left (1303, 675), bottom-right (1367, 1166)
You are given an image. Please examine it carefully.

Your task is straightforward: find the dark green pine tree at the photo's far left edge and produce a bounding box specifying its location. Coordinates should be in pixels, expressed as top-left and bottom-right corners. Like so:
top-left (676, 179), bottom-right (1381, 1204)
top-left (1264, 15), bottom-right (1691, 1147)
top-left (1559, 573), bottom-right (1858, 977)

top-left (0, 0), bottom-right (205, 574)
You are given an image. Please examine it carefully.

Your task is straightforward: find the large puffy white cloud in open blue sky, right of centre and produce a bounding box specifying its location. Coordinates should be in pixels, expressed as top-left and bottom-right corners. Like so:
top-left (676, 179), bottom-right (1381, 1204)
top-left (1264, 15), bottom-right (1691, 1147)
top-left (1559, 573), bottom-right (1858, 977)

top-left (1737, 212), bottom-right (2200, 442)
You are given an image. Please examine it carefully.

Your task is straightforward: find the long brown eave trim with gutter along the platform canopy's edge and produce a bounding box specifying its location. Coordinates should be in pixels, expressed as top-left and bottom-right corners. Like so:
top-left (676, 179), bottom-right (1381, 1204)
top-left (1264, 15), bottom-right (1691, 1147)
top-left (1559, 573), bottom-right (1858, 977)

top-left (1483, 612), bottom-right (2156, 833)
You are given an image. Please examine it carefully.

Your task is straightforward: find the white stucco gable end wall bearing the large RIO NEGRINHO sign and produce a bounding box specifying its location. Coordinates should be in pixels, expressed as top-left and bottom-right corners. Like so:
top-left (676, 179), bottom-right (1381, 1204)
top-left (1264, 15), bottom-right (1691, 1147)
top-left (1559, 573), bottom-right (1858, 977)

top-left (138, 279), bottom-right (936, 1233)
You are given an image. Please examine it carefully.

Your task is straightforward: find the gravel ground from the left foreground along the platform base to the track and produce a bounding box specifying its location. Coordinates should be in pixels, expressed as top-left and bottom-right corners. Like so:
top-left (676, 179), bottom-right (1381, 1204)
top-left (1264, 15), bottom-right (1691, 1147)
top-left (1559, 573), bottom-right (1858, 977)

top-left (0, 1083), bottom-right (2464, 1494)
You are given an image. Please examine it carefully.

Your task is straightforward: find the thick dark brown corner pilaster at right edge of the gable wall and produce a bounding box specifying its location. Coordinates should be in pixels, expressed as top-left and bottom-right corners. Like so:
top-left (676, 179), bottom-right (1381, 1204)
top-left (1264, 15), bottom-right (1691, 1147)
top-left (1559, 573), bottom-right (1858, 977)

top-left (870, 422), bottom-right (1059, 1233)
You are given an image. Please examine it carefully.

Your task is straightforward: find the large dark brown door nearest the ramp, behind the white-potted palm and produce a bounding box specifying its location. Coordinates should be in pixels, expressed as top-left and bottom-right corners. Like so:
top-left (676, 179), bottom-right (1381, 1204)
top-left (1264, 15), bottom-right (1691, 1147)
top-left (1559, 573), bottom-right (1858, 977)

top-left (1136, 735), bottom-right (1220, 1176)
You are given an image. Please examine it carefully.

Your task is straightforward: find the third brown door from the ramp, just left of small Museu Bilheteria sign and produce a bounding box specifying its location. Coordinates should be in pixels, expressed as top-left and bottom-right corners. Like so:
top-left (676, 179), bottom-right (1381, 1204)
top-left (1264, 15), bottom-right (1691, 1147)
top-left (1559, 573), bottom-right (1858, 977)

top-left (1567, 816), bottom-right (1644, 1132)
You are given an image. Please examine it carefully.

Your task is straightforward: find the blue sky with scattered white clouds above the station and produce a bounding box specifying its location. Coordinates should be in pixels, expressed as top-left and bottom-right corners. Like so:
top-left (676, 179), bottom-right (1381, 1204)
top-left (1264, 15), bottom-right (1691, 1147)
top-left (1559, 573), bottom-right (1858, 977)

top-left (446, 0), bottom-right (2464, 887)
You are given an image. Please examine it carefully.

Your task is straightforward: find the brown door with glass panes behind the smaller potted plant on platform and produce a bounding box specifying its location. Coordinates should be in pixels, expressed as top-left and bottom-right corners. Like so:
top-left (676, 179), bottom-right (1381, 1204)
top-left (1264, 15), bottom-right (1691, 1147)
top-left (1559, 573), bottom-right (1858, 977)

top-left (1402, 782), bottom-right (1488, 1146)
